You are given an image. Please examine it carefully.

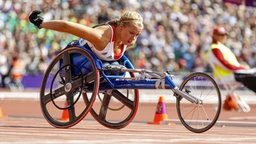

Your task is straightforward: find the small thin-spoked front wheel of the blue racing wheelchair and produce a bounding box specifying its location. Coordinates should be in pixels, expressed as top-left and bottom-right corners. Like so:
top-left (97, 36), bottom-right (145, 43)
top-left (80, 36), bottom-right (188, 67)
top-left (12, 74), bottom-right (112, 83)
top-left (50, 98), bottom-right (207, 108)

top-left (176, 72), bottom-right (221, 133)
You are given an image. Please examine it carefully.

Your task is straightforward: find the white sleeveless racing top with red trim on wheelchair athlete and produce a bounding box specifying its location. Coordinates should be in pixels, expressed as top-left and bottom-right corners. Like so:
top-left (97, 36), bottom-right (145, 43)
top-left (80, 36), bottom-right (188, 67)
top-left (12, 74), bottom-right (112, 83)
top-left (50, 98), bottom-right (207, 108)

top-left (79, 25), bottom-right (127, 61)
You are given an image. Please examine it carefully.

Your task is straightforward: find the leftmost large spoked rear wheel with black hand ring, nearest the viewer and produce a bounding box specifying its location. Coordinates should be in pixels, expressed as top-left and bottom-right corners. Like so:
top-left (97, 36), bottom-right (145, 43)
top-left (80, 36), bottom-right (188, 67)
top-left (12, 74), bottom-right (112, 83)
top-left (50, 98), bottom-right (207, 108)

top-left (40, 47), bottom-right (99, 128)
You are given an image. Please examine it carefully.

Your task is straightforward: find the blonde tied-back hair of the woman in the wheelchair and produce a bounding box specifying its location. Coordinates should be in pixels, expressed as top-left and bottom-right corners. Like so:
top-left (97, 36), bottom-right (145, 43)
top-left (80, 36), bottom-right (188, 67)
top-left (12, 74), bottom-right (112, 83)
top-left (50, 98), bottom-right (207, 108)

top-left (107, 11), bottom-right (143, 28)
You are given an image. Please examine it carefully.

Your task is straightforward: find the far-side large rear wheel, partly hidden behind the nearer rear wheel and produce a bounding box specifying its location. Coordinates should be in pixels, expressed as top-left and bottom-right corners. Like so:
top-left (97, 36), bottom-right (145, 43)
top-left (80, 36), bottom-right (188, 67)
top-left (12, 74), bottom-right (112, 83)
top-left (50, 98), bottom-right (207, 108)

top-left (85, 68), bottom-right (139, 129)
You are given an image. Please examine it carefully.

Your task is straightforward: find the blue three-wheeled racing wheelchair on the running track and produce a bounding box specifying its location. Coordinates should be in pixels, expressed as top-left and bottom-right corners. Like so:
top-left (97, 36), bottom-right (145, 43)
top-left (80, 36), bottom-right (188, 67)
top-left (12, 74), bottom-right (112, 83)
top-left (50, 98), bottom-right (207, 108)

top-left (40, 41), bottom-right (222, 133)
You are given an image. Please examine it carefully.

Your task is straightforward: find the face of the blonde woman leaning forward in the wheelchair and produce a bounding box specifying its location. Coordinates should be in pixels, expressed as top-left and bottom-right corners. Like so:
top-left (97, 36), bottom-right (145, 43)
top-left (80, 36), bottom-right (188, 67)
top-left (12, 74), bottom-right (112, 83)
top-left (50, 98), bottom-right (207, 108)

top-left (121, 23), bottom-right (143, 47)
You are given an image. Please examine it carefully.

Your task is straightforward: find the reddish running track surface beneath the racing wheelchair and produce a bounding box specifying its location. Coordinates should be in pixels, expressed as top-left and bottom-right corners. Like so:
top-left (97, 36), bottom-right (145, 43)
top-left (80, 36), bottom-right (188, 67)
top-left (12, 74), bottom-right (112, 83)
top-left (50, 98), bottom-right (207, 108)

top-left (0, 90), bottom-right (256, 144)
